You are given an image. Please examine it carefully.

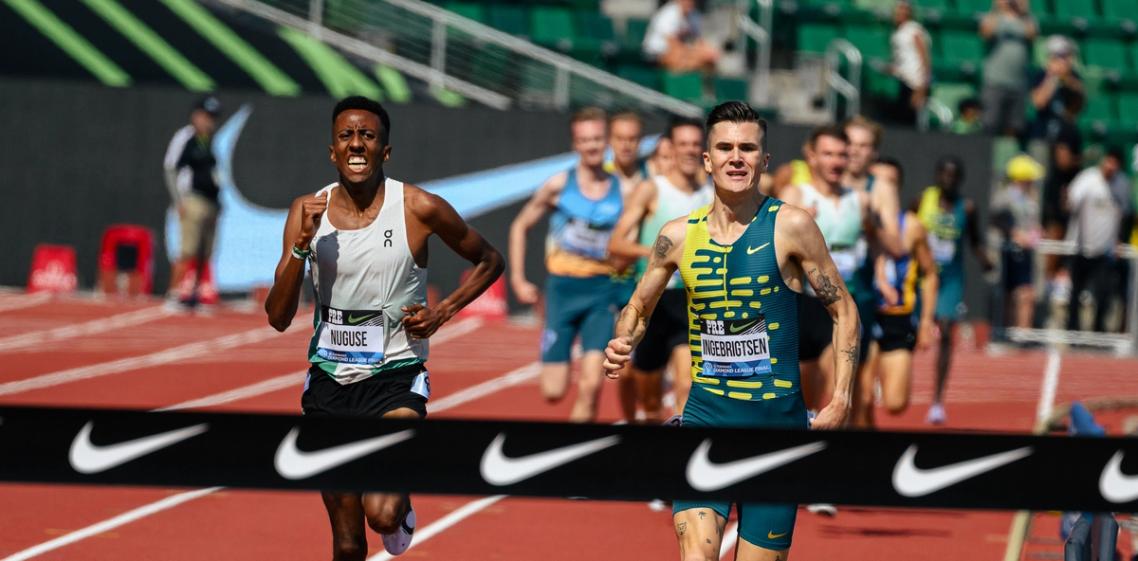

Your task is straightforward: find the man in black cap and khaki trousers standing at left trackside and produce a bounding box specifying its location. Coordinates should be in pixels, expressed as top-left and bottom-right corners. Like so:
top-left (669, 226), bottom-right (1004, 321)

top-left (163, 96), bottom-right (221, 306)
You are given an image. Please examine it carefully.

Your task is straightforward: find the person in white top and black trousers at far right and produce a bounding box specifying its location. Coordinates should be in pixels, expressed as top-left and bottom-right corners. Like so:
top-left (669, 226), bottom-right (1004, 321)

top-left (1067, 148), bottom-right (1133, 331)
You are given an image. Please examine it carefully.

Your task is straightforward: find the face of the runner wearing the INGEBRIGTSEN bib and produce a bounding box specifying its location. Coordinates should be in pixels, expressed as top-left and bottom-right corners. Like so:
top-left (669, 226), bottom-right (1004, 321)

top-left (703, 121), bottom-right (769, 193)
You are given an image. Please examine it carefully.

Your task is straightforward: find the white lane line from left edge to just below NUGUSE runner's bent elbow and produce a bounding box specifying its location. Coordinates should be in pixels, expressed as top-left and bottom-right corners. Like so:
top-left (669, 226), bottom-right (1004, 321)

top-left (0, 327), bottom-right (279, 396)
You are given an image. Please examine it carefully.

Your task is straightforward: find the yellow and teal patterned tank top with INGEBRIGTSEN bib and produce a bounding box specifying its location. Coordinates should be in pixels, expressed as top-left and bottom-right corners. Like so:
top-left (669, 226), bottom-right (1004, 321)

top-left (679, 197), bottom-right (799, 402)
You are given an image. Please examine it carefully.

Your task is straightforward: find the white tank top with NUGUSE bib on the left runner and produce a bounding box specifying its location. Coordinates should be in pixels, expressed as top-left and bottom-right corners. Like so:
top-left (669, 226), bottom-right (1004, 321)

top-left (308, 179), bottom-right (428, 383)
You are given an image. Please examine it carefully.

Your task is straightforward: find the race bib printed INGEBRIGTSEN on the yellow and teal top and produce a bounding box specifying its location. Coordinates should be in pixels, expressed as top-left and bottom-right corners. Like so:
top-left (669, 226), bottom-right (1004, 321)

top-left (700, 315), bottom-right (770, 378)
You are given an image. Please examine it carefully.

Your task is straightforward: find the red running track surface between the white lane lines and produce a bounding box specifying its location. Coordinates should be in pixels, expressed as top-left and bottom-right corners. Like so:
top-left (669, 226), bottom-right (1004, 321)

top-left (0, 295), bottom-right (1138, 561)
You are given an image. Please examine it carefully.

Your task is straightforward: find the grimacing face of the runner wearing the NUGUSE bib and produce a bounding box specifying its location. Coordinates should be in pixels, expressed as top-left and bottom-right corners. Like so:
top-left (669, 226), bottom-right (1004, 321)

top-left (329, 109), bottom-right (391, 183)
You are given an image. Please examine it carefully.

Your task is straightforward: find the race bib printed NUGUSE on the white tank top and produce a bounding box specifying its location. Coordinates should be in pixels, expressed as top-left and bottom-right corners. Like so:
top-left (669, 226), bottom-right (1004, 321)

top-left (316, 306), bottom-right (386, 364)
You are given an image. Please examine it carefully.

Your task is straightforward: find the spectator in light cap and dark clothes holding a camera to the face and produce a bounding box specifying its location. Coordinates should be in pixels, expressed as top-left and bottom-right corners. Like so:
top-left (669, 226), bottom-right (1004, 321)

top-left (1030, 35), bottom-right (1086, 141)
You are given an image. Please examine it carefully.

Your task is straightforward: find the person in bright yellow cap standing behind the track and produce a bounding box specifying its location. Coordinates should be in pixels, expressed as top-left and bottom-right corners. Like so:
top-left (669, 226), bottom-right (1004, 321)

top-left (991, 155), bottom-right (1044, 328)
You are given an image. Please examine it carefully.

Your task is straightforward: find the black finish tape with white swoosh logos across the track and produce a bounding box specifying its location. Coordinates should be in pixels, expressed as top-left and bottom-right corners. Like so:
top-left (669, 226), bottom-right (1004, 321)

top-left (0, 407), bottom-right (1138, 512)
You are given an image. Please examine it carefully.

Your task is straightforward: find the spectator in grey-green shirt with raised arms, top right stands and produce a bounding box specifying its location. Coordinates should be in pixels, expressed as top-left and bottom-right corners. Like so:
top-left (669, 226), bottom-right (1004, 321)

top-left (980, 0), bottom-right (1039, 137)
